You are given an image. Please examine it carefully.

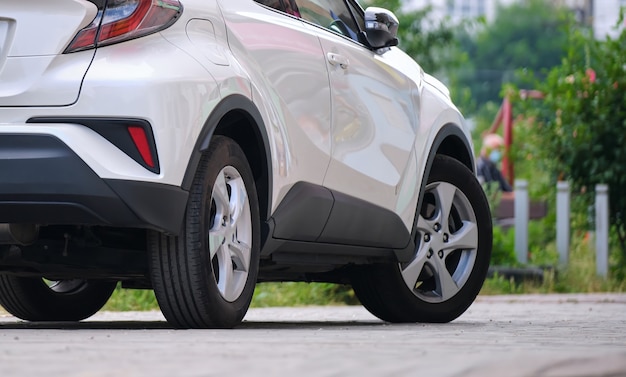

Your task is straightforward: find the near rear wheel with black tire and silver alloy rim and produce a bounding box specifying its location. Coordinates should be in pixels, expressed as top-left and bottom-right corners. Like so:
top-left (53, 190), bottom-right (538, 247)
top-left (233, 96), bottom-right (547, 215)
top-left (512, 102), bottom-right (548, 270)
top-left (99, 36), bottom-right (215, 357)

top-left (148, 136), bottom-right (260, 328)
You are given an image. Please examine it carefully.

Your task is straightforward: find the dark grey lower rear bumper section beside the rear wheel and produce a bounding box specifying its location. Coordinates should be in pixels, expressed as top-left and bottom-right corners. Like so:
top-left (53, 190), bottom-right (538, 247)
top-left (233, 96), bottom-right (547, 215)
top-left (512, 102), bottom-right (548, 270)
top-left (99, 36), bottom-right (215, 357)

top-left (0, 134), bottom-right (188, 234)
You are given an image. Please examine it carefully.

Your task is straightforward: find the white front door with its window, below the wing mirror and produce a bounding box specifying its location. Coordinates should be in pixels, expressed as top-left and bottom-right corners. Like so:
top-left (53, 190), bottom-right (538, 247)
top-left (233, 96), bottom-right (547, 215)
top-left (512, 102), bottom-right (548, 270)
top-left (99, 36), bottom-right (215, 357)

top-left (296, 0), bottom-right (419, 228)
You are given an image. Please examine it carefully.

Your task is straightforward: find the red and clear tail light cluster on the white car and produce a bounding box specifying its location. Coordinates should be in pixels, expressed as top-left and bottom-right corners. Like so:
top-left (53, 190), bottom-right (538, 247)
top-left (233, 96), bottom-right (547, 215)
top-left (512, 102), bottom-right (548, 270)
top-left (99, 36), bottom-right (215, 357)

top-left (65, 0), bottom-right (182, 53)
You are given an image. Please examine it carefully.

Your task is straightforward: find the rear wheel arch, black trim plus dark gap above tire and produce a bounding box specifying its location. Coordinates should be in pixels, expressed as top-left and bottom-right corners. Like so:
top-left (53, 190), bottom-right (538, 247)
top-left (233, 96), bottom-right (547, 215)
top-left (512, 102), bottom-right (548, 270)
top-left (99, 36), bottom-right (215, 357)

top-left (182, 94), bottom-right (272, 222)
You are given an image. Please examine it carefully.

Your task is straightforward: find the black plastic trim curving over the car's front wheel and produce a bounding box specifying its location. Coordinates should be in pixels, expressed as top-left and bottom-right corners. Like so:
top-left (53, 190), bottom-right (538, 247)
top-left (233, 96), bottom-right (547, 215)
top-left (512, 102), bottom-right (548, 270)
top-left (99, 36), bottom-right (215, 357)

top-left (395, 123), bottom-right (475, 262)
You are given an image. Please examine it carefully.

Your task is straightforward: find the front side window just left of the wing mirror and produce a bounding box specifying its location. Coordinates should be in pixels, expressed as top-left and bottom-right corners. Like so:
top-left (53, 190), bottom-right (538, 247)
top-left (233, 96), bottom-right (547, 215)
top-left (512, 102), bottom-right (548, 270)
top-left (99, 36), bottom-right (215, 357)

top-left (295, 0), bottom-right (360, 41)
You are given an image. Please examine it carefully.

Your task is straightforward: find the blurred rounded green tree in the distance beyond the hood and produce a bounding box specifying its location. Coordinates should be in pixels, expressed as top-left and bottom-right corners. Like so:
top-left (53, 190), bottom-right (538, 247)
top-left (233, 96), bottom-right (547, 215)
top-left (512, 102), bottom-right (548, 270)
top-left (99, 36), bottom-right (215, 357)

top-left (456, 0), bottom-right (568, 110)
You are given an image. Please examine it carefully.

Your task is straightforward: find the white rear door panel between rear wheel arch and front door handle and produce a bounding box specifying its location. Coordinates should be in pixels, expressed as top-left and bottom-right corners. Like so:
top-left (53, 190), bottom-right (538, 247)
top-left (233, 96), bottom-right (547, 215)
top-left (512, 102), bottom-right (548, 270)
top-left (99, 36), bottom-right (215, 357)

top-left (220, 0), bottom-right (331, 197)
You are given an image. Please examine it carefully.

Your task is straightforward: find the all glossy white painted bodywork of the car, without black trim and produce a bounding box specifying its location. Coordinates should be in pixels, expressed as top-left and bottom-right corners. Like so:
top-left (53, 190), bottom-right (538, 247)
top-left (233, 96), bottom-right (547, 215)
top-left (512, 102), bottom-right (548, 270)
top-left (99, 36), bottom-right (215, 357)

top-left (0, 0), bottom-right (471, 229)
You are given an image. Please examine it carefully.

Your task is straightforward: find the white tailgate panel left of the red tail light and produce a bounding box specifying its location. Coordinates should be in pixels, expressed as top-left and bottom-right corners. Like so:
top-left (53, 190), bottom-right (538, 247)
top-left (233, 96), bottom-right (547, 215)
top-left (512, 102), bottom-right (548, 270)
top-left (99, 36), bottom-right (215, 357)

top-left (0, 0), bottom-right (97, 107)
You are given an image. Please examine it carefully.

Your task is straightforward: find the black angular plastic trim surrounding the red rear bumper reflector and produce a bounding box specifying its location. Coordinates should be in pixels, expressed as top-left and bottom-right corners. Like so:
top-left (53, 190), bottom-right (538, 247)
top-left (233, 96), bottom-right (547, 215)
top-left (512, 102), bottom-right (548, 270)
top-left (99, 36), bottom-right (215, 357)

top-left (26, 117), bottom-right (161, 174)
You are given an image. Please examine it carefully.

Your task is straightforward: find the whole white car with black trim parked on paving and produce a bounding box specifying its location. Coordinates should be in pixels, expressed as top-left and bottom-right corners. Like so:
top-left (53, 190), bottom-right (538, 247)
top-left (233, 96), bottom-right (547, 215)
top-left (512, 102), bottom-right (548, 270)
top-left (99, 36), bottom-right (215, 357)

top-left (0, 0), bottom-right (492, 328)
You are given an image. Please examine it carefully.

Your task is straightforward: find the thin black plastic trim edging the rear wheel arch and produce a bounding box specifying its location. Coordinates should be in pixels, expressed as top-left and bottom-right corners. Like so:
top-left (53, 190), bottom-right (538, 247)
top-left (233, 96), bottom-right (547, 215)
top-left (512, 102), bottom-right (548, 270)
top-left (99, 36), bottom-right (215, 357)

top-left (181, 94), bottom-right (272, 221)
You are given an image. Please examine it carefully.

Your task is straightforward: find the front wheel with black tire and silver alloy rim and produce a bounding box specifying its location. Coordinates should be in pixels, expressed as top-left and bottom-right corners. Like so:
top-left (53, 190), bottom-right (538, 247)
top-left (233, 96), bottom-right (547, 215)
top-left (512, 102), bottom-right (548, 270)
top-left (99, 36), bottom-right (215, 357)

top-left (352, 156), bottom-right (492, 323)
